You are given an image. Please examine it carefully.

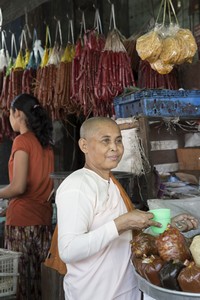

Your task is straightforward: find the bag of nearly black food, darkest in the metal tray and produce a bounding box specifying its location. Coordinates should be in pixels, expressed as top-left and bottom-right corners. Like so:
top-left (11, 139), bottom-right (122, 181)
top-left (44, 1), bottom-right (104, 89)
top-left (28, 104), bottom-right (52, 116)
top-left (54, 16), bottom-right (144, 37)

top-left (160, 260), bottom-right (185, 291)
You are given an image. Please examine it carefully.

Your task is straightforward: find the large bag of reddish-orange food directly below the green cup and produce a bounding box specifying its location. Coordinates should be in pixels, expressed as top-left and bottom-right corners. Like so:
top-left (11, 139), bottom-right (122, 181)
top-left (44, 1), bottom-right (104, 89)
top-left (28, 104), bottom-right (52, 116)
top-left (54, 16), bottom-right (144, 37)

top-left (156, 225), bottom-right (191, 262)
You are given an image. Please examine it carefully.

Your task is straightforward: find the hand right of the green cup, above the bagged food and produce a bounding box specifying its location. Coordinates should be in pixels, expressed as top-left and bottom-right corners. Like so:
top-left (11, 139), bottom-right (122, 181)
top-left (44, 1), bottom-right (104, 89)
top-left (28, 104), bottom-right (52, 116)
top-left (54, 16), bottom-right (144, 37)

top-left (171, 214), bottom-right (199, 232)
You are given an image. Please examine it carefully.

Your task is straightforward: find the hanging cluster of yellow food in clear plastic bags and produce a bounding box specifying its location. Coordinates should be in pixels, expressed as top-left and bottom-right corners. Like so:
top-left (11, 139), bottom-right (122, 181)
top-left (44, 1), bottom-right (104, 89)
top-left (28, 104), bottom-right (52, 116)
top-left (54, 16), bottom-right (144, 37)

top-left (136, 0), bottom-right (197, 74)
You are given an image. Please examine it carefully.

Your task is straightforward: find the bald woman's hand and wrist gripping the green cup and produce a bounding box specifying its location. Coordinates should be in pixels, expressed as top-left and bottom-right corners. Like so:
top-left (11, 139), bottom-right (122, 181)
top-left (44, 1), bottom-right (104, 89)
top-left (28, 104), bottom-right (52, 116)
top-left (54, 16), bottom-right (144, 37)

top-left (114, 209), bottom-right (162, 234)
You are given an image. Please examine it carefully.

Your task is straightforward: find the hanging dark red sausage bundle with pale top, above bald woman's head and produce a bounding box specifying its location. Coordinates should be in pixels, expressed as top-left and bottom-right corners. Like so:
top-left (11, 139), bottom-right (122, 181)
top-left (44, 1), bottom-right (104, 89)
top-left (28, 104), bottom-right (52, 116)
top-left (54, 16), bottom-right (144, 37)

top-left (94, 4), bottom-right (135, 116)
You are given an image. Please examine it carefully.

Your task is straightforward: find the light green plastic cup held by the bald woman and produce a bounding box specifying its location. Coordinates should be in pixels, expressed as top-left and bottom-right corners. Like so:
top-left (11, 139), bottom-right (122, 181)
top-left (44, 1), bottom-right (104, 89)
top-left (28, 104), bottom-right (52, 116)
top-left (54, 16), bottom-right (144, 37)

top-left (149, 208), bottom-right (171, 233)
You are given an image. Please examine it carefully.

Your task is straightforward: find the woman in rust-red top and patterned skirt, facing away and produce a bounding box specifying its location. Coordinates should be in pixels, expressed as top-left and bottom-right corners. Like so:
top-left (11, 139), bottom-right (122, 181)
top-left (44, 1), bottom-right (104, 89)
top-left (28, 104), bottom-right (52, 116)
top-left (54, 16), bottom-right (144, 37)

top-left (0, 94), bottom-right (54, 300)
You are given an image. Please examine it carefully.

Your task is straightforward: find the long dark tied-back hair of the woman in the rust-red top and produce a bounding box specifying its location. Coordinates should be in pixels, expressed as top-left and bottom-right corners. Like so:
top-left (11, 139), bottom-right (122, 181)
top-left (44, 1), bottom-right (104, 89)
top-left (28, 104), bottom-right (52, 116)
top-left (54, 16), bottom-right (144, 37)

top-left (10, 94), bottom-right (53, 148)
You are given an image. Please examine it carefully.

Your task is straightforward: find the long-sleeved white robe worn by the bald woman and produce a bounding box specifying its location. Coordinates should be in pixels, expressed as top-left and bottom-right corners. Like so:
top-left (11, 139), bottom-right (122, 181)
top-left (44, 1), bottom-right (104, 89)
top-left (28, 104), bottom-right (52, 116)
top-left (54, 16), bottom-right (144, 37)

top-left (56, 168), bottom-right (140, 300)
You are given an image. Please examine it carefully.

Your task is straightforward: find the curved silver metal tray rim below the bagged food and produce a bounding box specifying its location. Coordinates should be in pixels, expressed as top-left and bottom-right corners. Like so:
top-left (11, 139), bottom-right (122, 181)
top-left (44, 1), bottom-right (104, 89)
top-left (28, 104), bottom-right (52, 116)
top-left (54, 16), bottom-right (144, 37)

top-left (135, 272), bottom-right (200, 300)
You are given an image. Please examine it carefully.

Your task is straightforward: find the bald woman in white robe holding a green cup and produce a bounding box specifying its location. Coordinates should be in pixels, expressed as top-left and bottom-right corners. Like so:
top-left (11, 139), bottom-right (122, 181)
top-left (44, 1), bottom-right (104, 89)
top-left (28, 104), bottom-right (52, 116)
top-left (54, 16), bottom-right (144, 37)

top-left (56, 117), bottom-right (198, 300)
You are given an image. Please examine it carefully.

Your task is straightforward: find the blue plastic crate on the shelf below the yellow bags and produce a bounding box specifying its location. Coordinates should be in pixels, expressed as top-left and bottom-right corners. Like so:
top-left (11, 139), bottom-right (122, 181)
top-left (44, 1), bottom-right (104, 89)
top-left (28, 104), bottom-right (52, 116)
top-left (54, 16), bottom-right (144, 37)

top-left (114, 89), bottom-right (200, 118)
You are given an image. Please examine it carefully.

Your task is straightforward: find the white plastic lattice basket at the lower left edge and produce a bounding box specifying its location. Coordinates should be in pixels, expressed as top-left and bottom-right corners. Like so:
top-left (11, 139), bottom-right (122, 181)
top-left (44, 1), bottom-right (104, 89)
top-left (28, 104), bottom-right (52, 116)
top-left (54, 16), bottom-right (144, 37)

top-left (0, 248), bottom-right (21, 298)
